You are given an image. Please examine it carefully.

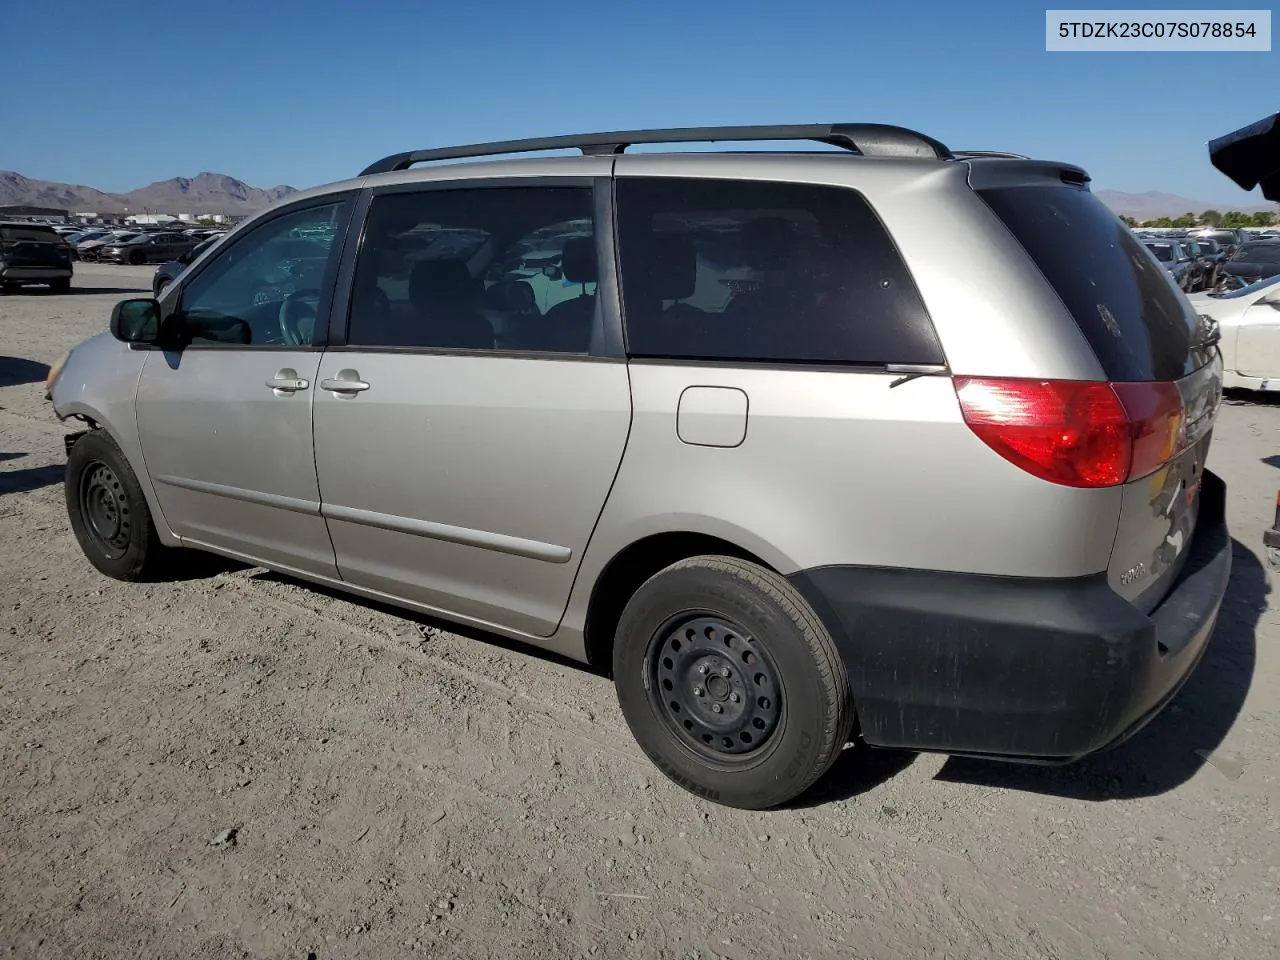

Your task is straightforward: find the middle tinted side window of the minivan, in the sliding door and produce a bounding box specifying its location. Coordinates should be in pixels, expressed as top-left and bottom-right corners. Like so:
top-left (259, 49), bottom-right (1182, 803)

top-left (347, 187), bottom-right (596, 353)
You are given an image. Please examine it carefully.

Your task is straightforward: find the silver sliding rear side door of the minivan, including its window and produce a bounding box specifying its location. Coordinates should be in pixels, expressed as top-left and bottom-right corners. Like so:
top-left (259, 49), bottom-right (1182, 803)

top-left (315, 182), bottom-right (631, 636)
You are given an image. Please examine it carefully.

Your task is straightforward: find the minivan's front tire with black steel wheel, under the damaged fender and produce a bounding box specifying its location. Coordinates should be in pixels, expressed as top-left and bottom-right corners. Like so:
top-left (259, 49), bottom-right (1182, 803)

top-left (64, 430), bottom-right (175, 581)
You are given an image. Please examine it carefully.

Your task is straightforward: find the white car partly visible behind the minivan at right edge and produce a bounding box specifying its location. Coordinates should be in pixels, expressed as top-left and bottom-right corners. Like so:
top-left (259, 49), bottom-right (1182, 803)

top-left (1189, 275), bottom-right (1280, 390)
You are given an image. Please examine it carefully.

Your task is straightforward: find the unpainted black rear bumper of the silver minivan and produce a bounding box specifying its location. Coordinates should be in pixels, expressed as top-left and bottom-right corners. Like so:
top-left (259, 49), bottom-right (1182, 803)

top-left (791, 472), bottom-right (1231, 762)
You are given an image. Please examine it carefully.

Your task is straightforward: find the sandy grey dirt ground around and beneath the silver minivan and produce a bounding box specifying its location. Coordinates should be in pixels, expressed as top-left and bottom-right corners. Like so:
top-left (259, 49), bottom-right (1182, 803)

top-left (0, 265), bottom-right (1280, 960)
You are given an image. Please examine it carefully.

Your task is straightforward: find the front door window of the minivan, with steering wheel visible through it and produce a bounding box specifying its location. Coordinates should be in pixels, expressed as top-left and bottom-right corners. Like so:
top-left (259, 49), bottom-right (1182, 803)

top-left (180, 202), bottom-right (343, 346)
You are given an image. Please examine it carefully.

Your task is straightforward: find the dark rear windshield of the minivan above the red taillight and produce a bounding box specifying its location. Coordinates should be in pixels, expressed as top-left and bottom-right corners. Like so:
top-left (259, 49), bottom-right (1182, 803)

top-left (978, 186), bottom-right (1204, 380)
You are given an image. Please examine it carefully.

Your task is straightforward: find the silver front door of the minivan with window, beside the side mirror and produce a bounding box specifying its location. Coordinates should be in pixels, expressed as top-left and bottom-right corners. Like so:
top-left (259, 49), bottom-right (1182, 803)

top-left (137, 196), bottom-right (351, 577)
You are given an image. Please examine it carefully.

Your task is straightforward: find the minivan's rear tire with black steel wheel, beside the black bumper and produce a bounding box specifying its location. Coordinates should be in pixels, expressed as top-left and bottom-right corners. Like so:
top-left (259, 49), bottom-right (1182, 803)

top-left (613, 557), bottom-right (854, 810)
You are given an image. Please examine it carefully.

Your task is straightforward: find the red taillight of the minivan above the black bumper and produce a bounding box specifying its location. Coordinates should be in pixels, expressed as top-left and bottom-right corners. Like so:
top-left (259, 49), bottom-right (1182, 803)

top-left (955, 376), bottom-right (1183, 486)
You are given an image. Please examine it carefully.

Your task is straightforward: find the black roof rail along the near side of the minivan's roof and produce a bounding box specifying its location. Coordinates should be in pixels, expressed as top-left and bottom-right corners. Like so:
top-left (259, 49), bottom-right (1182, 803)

top-left (360, 123), bottom-right (951, 177)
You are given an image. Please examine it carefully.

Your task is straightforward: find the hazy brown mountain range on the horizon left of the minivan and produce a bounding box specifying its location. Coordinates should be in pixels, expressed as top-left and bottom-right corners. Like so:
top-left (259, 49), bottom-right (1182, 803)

top-left (0, 170), bottom-right (297, 215)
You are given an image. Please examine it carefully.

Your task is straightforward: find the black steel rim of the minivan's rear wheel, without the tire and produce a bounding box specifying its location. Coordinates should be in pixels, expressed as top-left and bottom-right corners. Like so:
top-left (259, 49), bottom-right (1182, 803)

top-left (645, 616), bottom-right (782, 760)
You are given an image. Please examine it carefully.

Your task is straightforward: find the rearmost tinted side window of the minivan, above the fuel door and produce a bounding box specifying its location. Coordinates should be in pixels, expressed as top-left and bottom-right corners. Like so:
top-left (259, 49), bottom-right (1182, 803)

top-left (617, 178), bottom-right (942, 364)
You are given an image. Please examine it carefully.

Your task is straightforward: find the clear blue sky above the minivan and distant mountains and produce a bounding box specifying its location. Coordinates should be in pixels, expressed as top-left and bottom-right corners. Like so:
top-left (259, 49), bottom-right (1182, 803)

top-left (0, 0), bottom-right (1280, 205)
